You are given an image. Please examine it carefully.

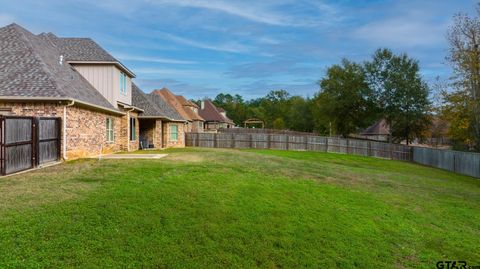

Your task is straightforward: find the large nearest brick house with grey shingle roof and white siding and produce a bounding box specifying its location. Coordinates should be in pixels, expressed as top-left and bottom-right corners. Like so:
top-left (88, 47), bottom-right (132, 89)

top-left (0, 24), bottom-right (186, 159)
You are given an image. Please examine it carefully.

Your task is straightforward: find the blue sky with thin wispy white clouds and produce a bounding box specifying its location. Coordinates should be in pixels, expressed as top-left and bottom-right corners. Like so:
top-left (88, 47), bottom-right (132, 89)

top-left (0, 0), bottom-right (476, 99)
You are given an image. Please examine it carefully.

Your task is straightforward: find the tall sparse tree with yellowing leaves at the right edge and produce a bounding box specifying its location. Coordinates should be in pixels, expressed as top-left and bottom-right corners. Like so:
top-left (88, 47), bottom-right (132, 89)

top-left (447, 4), bottom-right (480, 151)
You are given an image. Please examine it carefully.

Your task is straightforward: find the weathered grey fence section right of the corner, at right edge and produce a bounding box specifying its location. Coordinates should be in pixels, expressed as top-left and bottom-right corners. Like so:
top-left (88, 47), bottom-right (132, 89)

top-left (413, 147), bottom-right (480, 178)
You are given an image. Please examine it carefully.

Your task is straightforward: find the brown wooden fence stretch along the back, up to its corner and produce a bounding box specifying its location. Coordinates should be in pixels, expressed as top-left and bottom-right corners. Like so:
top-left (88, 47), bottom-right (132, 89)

top-left (185, 133), bottom-right (411, 161)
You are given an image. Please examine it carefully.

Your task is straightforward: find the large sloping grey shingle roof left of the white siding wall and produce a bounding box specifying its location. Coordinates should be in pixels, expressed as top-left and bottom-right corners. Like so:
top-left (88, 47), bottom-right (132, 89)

top-left (0, 24), bottom-right (116, 110)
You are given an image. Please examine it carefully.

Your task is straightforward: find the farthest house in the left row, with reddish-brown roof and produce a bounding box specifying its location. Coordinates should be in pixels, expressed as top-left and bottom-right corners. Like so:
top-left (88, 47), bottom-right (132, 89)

top-left (198, 99), bottom-right (235, 131)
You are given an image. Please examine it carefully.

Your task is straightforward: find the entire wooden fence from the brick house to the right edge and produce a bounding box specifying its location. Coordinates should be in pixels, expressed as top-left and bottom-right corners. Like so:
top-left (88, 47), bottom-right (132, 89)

top-left (185, 133), bottom-right (480, 178)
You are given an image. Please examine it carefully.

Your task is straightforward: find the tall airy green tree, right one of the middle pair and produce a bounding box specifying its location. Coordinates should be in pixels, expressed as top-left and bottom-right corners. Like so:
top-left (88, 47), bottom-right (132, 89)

top-left (365, 49), bottom-right (430, 144)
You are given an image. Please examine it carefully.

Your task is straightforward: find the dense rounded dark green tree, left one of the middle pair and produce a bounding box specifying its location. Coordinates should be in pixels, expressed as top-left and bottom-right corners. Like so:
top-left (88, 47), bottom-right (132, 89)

top-left (314, 59), bottom-right (375, 137)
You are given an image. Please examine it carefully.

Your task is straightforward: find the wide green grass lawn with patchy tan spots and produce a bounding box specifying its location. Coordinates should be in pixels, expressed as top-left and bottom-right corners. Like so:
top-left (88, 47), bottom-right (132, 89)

top-left (0, 149), bottom-right (480, 268)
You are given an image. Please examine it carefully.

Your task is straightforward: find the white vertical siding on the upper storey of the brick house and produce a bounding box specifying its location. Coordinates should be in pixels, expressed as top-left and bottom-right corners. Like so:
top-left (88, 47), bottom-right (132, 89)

top-left (75, 64), bottom-right (132, 107)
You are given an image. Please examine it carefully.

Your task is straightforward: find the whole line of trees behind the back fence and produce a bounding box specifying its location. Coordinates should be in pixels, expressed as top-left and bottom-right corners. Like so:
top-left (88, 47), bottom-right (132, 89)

top-left (213, 5), bottom-right (480, 151)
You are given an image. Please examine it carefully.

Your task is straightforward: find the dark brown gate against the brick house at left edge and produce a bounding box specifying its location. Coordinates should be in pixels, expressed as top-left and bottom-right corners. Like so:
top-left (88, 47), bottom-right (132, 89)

top-left (0, 116), bottom-right (61, 175)
